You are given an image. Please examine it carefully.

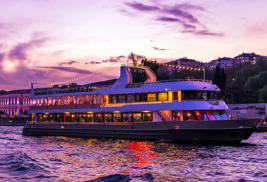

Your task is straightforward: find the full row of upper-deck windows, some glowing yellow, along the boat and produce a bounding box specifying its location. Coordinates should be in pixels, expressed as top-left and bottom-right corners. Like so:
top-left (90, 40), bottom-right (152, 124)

top-left (30, 91), bottom-right (219, 106)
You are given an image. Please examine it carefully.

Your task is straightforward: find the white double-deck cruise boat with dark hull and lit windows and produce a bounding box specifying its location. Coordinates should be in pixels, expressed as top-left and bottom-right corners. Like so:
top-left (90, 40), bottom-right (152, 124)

top-left (23, 56), bottom-right (260, 142)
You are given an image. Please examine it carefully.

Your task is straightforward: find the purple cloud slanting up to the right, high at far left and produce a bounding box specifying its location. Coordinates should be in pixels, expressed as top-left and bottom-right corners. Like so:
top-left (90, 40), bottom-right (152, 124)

top-left (8, 38), bottom-right (46, 61)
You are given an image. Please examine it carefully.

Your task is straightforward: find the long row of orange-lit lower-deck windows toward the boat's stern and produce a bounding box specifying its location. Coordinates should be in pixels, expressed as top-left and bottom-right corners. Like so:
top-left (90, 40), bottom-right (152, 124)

top-left (37, 112), bottom-right (153, 122)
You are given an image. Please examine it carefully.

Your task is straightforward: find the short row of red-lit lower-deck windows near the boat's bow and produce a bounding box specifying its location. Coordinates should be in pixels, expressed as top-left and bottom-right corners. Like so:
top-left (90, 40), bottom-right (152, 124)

top-left (175, 111), bottom-right (228, 121)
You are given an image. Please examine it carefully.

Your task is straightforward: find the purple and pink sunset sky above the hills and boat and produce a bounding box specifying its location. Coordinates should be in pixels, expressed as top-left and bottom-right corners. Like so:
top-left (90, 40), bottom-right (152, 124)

top-left (0, 0), bottom-right (267, 90)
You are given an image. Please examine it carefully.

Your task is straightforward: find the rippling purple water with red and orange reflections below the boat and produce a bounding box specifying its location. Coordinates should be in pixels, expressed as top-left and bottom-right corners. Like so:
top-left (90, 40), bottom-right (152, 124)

top-left (0, 126), bottom-right (267, 182)
